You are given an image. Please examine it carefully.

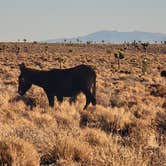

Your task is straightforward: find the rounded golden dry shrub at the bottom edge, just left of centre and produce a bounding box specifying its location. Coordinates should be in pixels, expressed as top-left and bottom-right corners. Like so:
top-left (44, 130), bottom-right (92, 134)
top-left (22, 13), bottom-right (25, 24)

top-left (46, 136), bottom-right (93, 166)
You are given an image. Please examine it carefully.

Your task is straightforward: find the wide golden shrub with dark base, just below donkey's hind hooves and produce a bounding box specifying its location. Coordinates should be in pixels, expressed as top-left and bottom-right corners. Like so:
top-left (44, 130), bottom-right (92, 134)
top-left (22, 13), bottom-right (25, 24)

top-left (80, 106), bottom-right (132, 136)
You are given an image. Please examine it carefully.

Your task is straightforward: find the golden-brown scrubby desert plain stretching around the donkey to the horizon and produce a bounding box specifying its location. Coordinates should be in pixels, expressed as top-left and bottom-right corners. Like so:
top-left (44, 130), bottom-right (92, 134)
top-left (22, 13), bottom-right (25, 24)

top-left (0, 41), bottom-right (166, 166)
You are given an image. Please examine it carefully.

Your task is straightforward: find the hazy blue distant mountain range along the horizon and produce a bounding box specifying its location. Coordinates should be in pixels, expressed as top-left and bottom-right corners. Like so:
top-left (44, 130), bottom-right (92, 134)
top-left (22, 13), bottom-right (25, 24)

top-left (46, 31), bottom-right (166, 43)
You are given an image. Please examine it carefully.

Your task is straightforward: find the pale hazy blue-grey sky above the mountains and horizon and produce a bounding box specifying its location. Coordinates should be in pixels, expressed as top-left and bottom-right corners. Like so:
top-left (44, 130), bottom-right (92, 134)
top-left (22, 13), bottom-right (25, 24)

top-left (0, 0), bottom-right (166, 41)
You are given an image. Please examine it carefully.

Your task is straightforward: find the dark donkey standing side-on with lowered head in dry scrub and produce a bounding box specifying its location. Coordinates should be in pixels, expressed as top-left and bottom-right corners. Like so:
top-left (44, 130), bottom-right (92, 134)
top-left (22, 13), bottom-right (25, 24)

top-left (18, 63), bottom-right (96, 109)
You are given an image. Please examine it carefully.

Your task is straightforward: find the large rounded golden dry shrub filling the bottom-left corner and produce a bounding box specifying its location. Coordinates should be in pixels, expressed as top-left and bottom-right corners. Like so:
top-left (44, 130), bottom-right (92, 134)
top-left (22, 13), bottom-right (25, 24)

top-left (0, 138), bottom-right (39, 166)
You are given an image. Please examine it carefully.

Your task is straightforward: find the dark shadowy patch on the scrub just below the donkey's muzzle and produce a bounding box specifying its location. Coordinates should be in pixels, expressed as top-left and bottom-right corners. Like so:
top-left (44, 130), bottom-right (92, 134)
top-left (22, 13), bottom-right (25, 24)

top-left (9, 95), bottom-right (36, 110)
